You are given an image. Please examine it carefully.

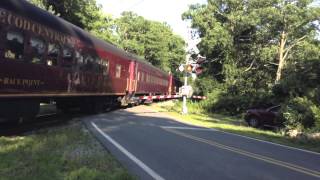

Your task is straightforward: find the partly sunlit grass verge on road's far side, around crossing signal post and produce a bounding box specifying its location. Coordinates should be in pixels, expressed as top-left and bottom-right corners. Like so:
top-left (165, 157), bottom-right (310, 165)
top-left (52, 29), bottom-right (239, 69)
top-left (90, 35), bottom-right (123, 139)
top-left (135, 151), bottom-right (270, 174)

top-left (151, 102), bottom-right (320, 152)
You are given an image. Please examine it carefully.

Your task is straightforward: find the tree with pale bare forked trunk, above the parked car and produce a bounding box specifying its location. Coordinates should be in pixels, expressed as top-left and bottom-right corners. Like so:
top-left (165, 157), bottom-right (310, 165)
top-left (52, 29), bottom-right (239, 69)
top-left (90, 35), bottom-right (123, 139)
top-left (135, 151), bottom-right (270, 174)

top-left (261, 0), bottom-right (320, 83)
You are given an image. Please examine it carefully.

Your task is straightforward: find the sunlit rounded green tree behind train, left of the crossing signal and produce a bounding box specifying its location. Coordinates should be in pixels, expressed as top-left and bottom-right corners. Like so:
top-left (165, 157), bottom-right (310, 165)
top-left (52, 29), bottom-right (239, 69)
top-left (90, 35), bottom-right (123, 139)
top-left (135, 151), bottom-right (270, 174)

top-left (115, 12), bottom-right (185, 72)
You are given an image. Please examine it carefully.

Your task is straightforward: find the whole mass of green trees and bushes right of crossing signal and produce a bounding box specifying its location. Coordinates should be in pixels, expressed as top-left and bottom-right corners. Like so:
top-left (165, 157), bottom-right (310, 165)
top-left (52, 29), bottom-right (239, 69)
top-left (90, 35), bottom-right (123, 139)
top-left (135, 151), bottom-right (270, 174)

top-left (182, 0), bottom-right (320, 132)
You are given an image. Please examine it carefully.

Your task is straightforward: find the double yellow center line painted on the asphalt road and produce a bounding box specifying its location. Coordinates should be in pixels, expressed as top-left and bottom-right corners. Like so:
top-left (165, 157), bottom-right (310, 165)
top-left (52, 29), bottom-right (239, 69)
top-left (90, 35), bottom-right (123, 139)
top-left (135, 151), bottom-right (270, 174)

top-left (163, 128), bottom-right (320, 178)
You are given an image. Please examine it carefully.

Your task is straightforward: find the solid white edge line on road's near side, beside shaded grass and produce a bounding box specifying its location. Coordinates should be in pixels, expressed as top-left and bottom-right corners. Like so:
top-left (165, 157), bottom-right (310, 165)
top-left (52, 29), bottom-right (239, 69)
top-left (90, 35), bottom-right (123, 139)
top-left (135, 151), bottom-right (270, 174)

top-left (91, 122), bottom-right (164, 180)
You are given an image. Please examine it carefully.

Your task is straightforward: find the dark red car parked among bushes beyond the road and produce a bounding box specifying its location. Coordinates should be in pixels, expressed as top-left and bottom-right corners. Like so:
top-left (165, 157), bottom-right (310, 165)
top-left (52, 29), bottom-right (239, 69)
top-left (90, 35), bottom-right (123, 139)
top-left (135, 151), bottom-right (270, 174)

top-left (244, 105), bottom-right (282, 128)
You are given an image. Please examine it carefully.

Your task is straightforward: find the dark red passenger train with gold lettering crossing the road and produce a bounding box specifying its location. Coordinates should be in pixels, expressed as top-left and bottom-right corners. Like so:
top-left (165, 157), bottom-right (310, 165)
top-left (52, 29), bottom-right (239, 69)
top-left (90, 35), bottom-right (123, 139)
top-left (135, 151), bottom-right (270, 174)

top-left (0, 0), bottom-right (178, 121)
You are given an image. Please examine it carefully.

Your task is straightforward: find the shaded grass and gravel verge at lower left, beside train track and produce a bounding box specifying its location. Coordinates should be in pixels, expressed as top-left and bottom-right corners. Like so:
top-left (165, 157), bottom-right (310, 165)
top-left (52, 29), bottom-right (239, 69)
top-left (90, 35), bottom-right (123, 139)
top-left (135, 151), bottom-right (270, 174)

top-left (0, 122), bottom-right (135, 180)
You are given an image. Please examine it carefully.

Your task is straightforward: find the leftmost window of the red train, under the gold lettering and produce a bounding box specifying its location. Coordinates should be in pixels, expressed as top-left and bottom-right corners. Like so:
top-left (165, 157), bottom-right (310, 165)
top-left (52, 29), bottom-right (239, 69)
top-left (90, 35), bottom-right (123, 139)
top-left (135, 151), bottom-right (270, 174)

top-left (4, 31), bottom-right (24, 60)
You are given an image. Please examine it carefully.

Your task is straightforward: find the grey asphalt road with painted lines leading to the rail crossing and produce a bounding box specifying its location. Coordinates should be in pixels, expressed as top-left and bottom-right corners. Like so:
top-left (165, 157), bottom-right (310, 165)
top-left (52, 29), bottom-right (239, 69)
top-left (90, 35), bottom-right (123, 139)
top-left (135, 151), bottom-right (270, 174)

top-left (83, 106), bottom-right (320, 180)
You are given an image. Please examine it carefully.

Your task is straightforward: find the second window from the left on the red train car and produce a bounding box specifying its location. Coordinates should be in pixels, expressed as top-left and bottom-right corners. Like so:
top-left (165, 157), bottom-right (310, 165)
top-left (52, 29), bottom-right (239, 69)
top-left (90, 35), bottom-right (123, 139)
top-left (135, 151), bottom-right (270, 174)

top-left (29, 37), bottom-right (45, 64)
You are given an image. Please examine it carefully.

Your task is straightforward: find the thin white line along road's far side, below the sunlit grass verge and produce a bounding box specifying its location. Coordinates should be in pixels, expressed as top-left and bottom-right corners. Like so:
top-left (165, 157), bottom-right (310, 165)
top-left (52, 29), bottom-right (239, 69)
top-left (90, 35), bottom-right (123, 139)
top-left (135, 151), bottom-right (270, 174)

top-left (161, 126), bottom-right (320, 156)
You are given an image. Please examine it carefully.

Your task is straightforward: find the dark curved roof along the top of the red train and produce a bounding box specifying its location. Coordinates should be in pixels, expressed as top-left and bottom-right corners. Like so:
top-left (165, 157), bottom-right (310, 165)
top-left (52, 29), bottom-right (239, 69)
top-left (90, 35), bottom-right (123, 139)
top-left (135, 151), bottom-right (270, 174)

top-left (0, 0), bottom-right (165, 73)
